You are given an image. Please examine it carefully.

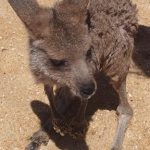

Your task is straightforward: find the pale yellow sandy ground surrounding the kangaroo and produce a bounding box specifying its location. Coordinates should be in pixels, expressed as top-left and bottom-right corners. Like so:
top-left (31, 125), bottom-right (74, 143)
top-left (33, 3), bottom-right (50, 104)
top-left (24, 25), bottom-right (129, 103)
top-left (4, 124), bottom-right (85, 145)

top-left (0, 0), bottom-right (150, 150)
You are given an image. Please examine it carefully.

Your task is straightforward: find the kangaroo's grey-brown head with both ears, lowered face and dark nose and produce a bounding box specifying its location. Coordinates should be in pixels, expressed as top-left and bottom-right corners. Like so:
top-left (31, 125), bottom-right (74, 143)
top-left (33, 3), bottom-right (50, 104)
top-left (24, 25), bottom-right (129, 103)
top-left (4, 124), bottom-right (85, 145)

top-left (9, 0), bottom-right (96, 98)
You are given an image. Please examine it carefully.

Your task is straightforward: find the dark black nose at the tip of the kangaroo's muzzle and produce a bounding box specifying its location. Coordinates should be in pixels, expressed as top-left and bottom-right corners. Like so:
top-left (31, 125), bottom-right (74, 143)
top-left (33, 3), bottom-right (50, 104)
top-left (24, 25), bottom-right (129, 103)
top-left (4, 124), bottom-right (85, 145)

top-left (80, 82), bottom-right (95, 98)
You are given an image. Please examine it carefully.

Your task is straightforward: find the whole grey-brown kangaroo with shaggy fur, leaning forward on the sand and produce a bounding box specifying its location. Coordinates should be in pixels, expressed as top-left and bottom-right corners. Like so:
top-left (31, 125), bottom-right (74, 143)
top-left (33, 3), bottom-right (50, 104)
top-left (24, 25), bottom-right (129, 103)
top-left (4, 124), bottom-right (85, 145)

top-left (9, 0), bottom-right (138, 150)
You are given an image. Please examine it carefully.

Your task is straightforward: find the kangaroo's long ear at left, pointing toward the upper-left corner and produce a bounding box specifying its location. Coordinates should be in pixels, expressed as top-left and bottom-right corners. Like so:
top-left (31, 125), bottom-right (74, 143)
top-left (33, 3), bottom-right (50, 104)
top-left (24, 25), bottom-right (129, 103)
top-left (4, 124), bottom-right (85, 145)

top-left (8, 0), bottom-right (53, 37)
